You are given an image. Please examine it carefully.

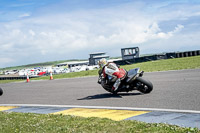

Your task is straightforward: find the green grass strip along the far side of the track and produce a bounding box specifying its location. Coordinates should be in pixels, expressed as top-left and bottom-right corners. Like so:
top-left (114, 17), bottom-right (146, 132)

top-left (0, 56), bottom-right (200, 84)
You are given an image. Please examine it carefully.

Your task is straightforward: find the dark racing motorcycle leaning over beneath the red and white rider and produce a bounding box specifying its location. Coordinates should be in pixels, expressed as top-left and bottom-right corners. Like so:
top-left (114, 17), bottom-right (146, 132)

top-left (98, 68), bottom-right (153, 94)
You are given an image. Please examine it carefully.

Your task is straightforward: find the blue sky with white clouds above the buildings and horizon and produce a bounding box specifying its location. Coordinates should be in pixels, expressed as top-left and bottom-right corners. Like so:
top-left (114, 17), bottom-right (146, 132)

top-left (0, 0), bottom-right (200, 68)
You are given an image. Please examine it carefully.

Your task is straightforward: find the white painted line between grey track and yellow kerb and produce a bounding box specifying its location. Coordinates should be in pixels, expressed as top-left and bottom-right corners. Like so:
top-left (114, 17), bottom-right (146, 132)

top-left (0, 104), bottom-right (200, 114)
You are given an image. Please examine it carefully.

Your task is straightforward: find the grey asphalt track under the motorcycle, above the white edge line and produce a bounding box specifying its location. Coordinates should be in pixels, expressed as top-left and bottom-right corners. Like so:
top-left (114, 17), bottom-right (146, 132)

top-left (0, 69), bottom-right (200, 111)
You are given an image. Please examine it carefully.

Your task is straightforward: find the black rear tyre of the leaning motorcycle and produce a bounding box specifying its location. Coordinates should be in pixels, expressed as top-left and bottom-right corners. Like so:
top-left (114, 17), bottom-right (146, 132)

top-left (136, 77), bottom-right (153, 94)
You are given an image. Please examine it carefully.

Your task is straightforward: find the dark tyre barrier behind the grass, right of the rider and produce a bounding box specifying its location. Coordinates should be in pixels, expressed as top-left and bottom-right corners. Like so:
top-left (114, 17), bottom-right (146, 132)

top-left (114, 50), bottom-right (200, 65)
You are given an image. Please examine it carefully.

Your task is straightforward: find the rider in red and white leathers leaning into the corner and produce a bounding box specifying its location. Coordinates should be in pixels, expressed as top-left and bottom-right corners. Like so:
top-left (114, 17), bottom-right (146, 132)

top-left (98, 58), bottom-right (126, 92)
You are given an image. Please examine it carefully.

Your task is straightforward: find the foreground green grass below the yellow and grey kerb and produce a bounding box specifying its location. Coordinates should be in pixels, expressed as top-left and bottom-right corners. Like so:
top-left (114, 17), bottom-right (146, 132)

top-left (0, 112), bottom-right (200, 133)
